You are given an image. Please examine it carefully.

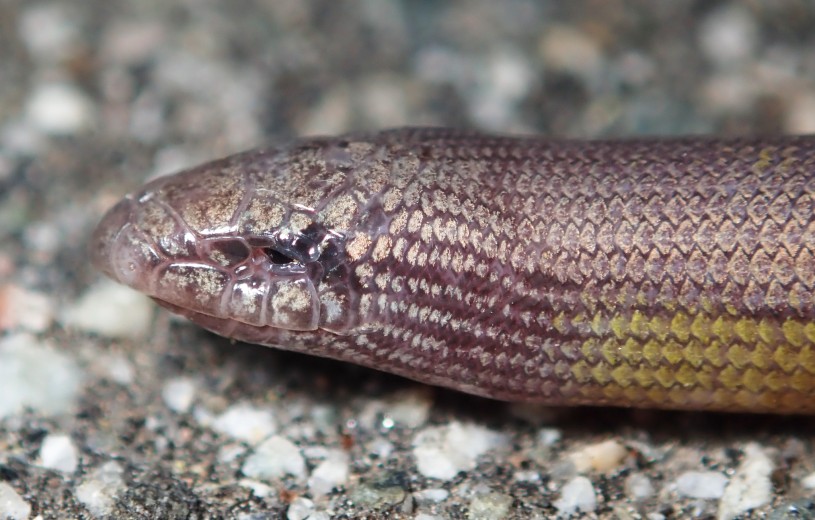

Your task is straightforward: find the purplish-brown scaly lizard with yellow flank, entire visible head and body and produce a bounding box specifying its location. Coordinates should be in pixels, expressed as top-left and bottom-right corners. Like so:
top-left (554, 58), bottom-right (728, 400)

top-left (93, 129), bottom-right (815, 413)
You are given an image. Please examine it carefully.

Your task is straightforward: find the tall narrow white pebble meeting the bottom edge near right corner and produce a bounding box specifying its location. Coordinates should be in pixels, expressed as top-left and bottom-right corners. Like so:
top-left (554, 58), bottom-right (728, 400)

top-left (718, 443), bottom-right (774, 520)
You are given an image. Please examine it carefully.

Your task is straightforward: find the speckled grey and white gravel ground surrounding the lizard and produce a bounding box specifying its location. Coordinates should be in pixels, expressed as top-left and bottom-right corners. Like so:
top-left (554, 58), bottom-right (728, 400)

top-left (0, 0), bottom-right (815, 520)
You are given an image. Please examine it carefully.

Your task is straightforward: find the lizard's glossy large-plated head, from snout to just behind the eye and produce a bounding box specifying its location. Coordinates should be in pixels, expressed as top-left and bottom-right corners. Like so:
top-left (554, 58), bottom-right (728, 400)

top-left (92, 140), bottom-right (384, 333)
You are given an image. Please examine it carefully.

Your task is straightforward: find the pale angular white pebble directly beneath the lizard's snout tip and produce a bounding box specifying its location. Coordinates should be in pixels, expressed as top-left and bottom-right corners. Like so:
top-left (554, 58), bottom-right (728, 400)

top-left (61, 280), bottom-right (155, 339)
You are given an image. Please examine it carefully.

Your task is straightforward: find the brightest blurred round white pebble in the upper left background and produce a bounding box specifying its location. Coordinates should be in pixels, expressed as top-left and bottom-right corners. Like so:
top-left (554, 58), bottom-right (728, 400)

top-left (26, 83), bottom-right (94, 135)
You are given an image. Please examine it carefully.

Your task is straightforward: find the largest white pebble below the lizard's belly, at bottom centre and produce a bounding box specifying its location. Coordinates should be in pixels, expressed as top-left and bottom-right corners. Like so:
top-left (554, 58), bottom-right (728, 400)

top-left (413, 422), bottom-right (507, 480)
